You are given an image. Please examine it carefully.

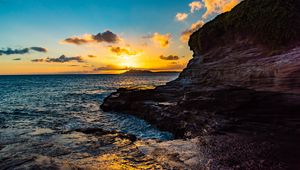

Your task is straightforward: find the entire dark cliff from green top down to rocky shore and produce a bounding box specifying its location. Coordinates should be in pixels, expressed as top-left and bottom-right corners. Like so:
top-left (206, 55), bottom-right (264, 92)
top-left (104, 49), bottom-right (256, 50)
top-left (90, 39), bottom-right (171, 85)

top-left (101, 0), bottom-right (300, 169)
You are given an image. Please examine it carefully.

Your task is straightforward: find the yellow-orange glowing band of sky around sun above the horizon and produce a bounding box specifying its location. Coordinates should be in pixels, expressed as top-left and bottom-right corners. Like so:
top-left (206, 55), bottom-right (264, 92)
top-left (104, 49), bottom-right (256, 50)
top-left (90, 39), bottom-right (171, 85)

top-left (0, 35), bottom-right (191, 75)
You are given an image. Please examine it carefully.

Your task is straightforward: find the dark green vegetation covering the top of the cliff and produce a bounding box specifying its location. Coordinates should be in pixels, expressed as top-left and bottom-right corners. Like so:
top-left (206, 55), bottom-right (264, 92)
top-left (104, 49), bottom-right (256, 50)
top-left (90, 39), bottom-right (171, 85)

top-left (189, 0), bottom-right (300, 53)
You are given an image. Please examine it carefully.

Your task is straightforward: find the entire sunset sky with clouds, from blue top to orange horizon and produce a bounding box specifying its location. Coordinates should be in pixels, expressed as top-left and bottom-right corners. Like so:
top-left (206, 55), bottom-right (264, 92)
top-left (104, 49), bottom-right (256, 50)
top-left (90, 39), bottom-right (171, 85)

top-left (0, 0), bottom-right (239, 74)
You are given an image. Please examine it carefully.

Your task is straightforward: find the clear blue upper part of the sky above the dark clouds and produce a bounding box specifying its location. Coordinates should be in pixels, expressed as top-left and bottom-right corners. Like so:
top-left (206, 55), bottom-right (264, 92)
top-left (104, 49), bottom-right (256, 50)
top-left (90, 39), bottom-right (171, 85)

top-left (0, 0), bottom-right (202, 45)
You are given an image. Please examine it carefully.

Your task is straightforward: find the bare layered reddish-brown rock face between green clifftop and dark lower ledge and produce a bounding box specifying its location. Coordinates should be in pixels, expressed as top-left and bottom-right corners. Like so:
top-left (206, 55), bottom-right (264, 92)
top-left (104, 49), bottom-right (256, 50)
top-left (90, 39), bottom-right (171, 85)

top-left (172, 43), bottom-right (300, 94)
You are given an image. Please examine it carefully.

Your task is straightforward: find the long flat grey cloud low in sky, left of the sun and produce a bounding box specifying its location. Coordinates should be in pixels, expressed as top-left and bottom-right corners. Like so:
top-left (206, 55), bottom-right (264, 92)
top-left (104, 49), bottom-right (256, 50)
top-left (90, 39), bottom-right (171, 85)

top-left (31, 55), bottom-right (84, 63)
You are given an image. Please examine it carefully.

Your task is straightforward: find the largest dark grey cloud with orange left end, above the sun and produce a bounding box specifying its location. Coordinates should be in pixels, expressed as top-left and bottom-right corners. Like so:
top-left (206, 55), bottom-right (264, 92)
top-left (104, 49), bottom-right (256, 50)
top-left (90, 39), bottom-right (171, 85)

top-left (62, 30), bottom-right (120, 45)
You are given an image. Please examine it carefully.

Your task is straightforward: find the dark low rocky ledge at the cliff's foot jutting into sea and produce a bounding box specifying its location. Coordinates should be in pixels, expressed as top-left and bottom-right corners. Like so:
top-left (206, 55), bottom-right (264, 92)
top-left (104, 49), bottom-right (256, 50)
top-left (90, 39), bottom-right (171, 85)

top-left (102, 86), bottom-right (300, 169)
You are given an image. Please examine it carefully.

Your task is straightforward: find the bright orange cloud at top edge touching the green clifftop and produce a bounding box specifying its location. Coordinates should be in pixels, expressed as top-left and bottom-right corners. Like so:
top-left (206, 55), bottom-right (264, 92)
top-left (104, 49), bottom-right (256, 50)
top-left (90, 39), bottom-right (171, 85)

top-left (203, 0), bottom-right (241, 19)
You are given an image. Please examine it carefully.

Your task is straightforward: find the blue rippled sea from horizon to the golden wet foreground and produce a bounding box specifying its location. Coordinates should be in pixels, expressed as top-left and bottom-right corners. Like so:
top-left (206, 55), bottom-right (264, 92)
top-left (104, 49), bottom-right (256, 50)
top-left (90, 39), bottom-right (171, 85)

top-left (0, 74), bottom-right (177, 169)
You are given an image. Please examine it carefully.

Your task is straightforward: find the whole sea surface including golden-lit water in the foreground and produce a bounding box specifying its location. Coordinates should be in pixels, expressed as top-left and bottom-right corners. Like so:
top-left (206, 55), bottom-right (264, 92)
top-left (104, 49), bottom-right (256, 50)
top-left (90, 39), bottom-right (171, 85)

top-left (0, 74), bottom-right (177, 169)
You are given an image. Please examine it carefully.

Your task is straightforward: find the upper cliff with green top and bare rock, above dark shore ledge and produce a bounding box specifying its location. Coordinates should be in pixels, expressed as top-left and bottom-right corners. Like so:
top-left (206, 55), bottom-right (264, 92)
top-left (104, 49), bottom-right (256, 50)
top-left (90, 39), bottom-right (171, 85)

top-left (176, 0), bottom-right (300, 93)
